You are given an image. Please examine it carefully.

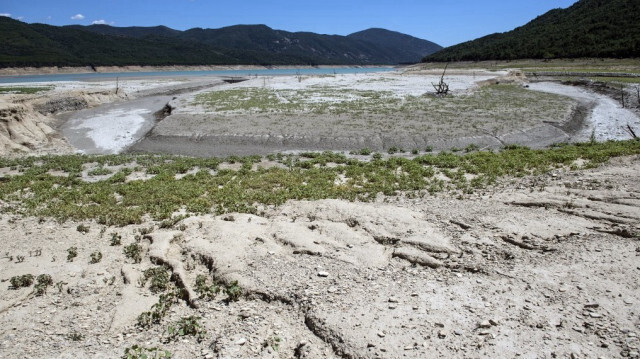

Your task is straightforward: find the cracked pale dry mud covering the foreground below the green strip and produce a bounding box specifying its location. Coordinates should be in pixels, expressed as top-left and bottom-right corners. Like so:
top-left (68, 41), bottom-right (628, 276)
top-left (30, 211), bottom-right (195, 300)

top-left (0, 156), bottom-right (640, 358)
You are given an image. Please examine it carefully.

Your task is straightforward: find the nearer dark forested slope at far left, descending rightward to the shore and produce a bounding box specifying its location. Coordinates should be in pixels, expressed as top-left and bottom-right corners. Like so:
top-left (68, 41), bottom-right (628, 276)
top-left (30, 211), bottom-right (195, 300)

top-left (0, 17), bottom-right (260, 67)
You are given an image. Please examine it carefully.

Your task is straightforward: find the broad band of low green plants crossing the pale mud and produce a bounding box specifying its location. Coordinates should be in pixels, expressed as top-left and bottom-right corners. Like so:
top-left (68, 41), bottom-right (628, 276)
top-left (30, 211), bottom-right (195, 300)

top-left (0, 140), bottom-right (640, 225)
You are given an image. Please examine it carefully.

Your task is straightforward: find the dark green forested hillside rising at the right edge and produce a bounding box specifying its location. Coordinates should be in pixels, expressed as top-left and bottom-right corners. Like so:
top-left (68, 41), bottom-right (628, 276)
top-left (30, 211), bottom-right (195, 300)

top-left (423, 0), bottom-right (640, 61)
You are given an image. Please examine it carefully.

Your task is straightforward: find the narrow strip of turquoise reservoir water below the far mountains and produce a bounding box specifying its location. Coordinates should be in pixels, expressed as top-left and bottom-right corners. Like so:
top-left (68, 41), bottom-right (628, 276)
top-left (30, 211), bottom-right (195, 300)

top-left (0, 67), bottom-right (395, 84)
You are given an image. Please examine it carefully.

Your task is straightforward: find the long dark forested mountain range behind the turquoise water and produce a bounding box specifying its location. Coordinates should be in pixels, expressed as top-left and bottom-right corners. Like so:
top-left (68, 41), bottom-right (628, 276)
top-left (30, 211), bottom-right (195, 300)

top-left (0, 17), bottom-right (438, 67)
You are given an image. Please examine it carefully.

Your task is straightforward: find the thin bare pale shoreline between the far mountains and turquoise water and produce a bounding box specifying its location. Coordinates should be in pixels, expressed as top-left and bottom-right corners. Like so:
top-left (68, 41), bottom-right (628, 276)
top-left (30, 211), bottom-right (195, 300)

top-left (0, 65), bottom-right (396, 76)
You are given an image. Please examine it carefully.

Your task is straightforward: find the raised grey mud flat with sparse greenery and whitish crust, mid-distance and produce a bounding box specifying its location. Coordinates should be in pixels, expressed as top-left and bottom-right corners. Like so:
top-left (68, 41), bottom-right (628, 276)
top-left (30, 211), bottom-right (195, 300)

top-left (130, 71), bottom-right (577, 156)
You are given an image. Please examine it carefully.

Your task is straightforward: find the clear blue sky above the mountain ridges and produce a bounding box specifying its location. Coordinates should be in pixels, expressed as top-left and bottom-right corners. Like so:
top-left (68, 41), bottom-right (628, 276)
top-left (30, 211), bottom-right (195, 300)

top-left (0, 0), bottom-right (576, 46)
